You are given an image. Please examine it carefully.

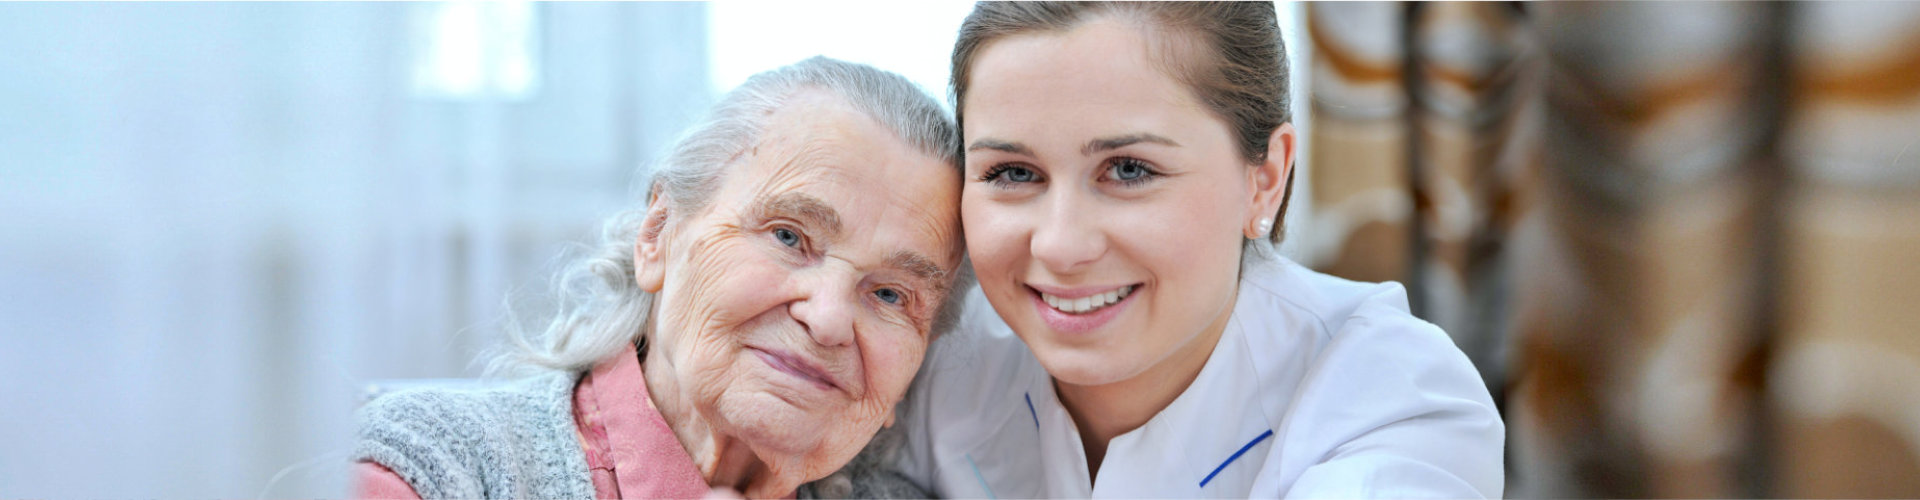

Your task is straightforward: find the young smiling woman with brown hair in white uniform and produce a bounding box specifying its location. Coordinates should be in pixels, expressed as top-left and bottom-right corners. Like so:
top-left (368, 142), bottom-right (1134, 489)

top-left (897, 2), bottom-right (1503, 498)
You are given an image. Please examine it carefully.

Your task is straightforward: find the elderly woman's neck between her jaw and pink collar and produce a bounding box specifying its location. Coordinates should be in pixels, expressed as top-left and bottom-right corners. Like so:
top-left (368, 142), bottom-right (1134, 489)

top-left (639, 338), bottom-right (801, 498)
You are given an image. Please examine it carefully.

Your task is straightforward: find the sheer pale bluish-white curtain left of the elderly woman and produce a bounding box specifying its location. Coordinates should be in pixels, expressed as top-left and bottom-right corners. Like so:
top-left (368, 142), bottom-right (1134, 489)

top-left (0, 4), bottom-right (712, 498)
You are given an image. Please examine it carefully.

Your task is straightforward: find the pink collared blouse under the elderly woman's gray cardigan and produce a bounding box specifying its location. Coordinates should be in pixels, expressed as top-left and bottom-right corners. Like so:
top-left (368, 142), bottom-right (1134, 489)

top-left (353, 346), bottom-right (708, 498)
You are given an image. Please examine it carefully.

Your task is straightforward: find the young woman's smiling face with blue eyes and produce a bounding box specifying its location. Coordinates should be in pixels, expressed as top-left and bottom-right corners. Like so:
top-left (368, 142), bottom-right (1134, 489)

top-left (960, 19), bottom-right (1256, 385)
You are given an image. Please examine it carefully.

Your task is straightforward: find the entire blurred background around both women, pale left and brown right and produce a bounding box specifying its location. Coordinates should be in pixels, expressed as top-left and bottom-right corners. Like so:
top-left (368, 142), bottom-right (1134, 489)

top-left (0, 2), bottom-right (1920, 498)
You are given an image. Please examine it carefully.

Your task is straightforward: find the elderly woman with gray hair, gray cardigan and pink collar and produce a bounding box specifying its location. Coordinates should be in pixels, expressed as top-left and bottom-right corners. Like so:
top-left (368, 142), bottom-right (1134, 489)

top-left (355, 58), bottom-right (964, 498)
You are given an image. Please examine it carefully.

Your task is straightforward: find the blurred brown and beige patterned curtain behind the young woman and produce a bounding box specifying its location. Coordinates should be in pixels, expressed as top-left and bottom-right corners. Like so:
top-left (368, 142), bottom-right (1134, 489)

top-left (1300, 2), bottom-right (1920, 498)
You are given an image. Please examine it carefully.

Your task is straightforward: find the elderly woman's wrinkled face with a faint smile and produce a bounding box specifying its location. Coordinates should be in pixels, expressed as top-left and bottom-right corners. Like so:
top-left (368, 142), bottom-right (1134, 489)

top-left (639, 90), bottom-right (962, 481)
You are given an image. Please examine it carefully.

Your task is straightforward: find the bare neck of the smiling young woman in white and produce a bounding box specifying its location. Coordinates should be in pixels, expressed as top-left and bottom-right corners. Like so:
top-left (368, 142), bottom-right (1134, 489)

top-left (1054, 282), bottom-right (1236, 479)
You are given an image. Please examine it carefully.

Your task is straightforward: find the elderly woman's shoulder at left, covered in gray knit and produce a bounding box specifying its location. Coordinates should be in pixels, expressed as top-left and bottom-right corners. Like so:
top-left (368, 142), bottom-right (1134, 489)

top-left (353, 371), bottom-right (586, 498)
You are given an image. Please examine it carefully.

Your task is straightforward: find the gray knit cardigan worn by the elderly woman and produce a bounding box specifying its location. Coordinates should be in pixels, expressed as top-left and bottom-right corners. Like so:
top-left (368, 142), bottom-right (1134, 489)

top-left (353, 371), bottom-right (927, 498)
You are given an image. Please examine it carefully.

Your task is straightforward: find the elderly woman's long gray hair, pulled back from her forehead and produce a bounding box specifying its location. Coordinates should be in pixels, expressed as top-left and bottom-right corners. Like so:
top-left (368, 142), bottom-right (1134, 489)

top-left (490, 56), bottom-right (972, 373)
